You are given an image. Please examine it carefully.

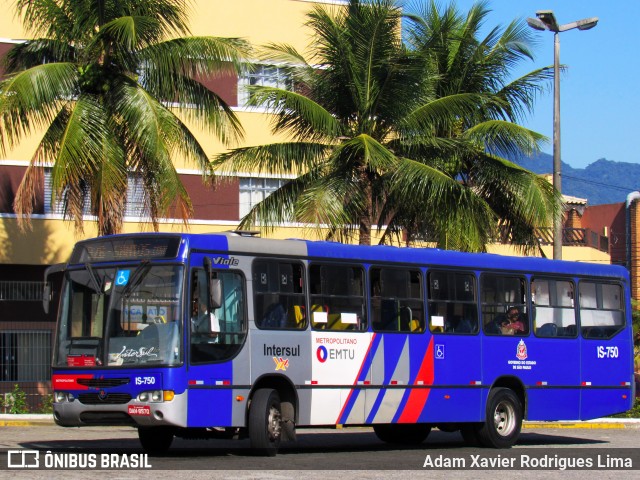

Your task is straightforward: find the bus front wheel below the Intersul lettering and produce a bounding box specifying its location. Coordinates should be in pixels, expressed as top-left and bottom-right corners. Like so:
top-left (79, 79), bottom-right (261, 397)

top-left (249, 388), bottom-right (282, 457)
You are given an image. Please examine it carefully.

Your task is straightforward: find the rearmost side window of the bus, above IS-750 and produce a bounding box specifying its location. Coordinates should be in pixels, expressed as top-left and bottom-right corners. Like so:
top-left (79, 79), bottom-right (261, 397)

top-left (578, 281), bottom-right (625, 339)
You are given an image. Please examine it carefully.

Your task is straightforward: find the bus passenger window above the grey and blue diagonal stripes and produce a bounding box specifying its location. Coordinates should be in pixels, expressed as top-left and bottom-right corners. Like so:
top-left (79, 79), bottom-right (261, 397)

top-left (369, 267), bottom-right (424, 333)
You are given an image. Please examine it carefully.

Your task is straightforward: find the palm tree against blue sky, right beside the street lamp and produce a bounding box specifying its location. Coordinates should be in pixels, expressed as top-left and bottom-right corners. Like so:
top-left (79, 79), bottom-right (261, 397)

top-left (406, 2), bottom-right (560, 251)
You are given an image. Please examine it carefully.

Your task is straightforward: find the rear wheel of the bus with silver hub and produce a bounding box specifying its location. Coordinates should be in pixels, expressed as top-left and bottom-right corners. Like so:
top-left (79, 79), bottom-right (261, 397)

top-left (478, 388), bottom-right (522, 448)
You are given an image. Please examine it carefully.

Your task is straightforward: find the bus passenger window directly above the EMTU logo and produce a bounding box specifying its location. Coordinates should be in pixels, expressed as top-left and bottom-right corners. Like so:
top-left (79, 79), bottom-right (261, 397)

top-left (309, 264), bottom-right (367, 331)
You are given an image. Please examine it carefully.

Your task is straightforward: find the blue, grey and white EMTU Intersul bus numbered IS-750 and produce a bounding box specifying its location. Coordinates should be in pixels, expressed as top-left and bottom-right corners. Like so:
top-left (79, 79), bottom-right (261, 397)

top-left (45, 233), bottom-right (634, 455)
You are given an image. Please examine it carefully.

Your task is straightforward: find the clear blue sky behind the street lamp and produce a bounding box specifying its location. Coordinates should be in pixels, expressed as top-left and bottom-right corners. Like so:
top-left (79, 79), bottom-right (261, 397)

top-left (404, 0), bottom-right (640, 168)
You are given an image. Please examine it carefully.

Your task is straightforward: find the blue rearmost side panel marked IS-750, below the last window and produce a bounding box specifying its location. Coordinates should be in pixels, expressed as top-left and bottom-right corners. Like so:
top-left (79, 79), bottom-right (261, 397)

top-left (580, 329), bottom-right (634, 420)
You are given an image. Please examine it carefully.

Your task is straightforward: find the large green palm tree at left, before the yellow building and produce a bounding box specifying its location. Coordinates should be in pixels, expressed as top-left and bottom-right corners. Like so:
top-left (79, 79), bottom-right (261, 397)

top-left (0, 0), bottom-right (248, 235)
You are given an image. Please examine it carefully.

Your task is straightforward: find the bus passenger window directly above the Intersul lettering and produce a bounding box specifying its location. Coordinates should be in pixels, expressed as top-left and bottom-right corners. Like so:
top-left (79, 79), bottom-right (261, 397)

top-left (253, 260), bottom-right (307, 330)
